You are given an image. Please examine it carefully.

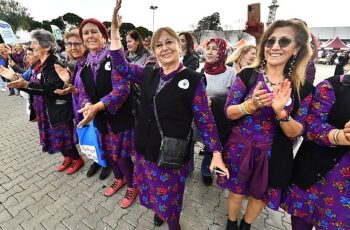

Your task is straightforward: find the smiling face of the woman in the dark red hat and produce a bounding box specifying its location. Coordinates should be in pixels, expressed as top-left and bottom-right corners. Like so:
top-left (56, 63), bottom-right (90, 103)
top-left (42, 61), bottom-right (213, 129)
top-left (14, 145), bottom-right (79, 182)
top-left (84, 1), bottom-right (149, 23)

top-left (82, 23), bottom-right (106, 53)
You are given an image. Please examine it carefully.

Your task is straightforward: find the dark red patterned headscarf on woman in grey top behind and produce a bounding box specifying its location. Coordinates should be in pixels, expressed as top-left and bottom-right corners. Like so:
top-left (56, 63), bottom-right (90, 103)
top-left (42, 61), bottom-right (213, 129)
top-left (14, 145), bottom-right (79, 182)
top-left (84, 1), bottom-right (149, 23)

top-left (204, 37), bottom-right (227, 75)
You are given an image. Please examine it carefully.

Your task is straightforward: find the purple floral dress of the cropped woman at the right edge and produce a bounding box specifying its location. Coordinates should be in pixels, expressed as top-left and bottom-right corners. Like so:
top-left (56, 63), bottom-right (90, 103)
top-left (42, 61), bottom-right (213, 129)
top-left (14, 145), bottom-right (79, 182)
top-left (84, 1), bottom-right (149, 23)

top-left (281, 80), bottom-right (350, 230)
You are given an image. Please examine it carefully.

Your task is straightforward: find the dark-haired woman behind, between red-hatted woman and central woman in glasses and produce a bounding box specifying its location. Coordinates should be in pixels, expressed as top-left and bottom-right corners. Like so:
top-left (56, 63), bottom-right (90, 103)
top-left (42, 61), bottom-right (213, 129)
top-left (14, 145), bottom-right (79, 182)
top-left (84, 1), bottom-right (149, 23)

top-left (126, 30), bottom-right (152, 66)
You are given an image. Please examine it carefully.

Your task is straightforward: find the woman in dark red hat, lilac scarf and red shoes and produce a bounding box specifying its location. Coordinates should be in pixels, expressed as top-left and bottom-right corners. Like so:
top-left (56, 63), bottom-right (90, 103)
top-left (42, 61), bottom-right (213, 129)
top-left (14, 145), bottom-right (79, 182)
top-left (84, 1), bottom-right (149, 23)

top-left (78, 18), bottom-right (137, 208)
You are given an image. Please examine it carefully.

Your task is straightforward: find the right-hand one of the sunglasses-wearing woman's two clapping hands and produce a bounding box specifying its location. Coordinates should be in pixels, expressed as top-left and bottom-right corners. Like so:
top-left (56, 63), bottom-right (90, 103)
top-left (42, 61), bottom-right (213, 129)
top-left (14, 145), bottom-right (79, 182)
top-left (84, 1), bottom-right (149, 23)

top-left (271, 79), bottom-right (292, 115)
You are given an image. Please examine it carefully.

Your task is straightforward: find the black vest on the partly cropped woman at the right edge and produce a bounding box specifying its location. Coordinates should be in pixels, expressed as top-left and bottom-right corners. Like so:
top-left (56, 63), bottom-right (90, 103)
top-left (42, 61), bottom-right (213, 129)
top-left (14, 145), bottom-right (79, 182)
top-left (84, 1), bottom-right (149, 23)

top-left (292, 76), bottom-right (350, 190)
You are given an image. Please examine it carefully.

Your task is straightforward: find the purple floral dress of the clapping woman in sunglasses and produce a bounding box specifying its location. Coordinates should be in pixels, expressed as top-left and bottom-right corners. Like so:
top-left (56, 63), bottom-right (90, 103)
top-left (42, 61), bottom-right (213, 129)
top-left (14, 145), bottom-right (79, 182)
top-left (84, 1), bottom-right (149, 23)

top-left (217, 74), bottom-right (312, 210)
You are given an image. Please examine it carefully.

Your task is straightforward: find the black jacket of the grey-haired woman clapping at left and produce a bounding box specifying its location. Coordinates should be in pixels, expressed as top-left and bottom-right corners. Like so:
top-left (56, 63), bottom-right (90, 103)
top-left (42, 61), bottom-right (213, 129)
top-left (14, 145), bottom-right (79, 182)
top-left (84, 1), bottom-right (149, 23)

top-left (21, 54), bottom-right (73, 126)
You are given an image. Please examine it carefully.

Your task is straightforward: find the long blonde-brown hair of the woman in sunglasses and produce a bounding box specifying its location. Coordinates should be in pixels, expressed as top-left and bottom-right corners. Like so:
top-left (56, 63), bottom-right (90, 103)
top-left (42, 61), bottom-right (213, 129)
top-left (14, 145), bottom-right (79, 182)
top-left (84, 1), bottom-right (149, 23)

top-left (252, 20), bottom-right (311, 98)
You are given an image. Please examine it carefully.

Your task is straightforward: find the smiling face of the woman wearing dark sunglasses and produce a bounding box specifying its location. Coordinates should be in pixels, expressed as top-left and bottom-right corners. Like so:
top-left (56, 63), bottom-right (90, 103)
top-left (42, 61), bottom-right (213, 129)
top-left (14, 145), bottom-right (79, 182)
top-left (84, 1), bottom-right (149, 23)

top-left (264, 27), bottom-right (299, 67)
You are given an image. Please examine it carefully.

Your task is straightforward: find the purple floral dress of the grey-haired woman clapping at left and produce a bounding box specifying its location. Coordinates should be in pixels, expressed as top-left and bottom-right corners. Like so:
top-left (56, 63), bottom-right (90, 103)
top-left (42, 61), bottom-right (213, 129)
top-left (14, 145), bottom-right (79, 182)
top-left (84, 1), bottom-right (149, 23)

top-left (30, 63), bottom-right (78, 154)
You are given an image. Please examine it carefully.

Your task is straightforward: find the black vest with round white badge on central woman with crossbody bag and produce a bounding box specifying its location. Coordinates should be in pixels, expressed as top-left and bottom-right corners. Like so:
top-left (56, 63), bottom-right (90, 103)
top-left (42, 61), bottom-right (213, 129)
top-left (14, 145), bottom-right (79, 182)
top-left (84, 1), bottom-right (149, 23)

top-left (135, 68), bottom-right (202, 162)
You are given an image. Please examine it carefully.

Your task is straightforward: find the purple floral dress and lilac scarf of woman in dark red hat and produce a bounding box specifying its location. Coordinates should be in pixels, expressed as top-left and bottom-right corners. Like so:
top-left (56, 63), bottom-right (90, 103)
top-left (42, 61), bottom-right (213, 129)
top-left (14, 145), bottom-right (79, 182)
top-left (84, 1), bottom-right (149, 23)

top-left (79, 47), bottom-right (134, 161)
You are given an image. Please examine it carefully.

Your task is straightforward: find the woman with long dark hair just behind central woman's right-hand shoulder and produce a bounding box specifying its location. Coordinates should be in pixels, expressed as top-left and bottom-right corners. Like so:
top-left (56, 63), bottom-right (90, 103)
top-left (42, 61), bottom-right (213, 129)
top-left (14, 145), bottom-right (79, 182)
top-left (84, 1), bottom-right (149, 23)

top-left (179, 32), bottom-right (199, 70)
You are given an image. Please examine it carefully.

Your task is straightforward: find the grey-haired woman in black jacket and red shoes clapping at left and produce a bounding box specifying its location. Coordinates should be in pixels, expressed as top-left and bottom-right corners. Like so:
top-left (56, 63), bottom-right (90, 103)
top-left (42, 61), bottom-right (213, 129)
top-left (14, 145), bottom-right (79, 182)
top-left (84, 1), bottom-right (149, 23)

top-left (8, 30), bottom-right (84, 174)
